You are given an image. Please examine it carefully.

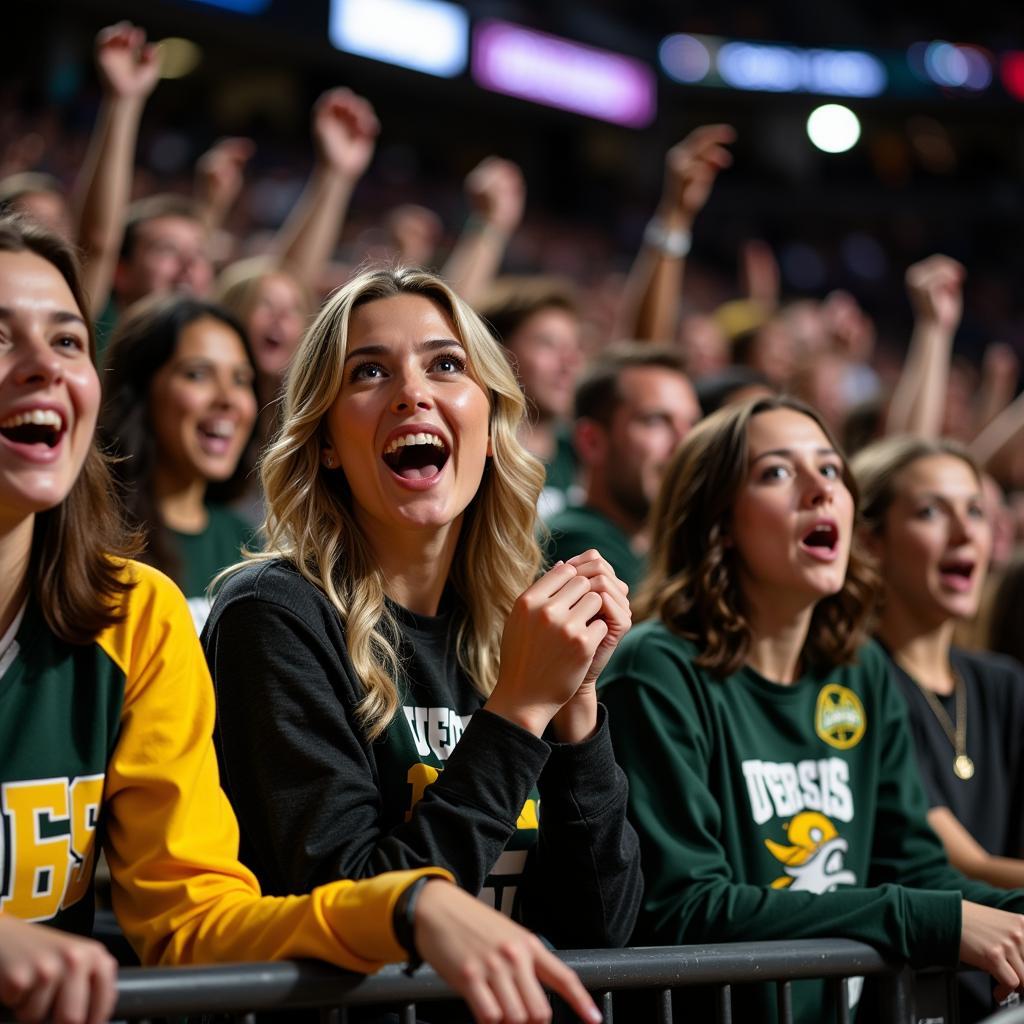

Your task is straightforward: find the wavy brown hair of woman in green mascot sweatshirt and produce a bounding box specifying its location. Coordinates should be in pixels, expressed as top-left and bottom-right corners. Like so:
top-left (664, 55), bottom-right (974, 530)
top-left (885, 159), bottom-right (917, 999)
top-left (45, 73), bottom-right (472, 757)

top-left (635, 395), bottom-right (876, 677)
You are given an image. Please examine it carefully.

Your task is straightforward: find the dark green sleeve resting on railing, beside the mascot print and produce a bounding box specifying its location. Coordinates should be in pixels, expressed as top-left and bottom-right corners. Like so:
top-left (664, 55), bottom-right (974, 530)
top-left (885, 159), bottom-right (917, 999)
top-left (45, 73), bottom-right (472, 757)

top-left (601, 642), bottom-right (959, 966)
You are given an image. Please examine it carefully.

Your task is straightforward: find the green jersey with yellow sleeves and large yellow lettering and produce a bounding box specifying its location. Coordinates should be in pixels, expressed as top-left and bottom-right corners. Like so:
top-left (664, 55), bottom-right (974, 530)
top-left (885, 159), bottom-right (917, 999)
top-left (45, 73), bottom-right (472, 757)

top-left (0, 561), bottom-right (446, 971)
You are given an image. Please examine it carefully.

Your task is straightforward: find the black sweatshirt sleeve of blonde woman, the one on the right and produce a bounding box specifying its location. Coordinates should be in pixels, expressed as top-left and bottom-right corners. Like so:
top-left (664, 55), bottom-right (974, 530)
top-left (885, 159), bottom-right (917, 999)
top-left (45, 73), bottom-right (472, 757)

top-left (523, 705), bottom-right (643, 949)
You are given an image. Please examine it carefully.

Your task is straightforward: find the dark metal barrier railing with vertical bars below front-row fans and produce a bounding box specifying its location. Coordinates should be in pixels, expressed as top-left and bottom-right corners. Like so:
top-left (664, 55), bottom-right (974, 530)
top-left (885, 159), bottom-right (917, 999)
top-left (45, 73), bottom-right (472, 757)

top-left (77, 939), bottom-right (958, 1024)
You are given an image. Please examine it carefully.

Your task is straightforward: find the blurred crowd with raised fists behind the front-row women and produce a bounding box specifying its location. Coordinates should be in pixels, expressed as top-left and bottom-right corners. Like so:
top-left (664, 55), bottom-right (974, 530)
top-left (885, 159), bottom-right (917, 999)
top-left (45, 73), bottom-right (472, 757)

top-left (0, 25), bottom-right (1024, 626)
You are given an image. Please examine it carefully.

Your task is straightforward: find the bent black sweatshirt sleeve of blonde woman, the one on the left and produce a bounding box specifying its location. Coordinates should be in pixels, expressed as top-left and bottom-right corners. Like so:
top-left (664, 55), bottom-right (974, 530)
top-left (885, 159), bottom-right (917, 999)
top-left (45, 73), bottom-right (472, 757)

top-left (204, 595), bottom-right (549, 893)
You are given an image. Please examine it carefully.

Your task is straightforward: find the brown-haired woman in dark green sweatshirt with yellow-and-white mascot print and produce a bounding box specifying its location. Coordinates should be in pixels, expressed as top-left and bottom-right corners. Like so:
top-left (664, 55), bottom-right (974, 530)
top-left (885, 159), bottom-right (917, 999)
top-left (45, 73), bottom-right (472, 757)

top-left (601, 397), bottom-right (1024, 1021)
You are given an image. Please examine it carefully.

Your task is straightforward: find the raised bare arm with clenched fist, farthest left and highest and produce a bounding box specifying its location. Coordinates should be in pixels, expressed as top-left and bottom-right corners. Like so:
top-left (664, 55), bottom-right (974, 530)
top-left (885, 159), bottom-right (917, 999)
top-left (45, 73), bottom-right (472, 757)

top-left (73, 22), bottom-right (160, 317)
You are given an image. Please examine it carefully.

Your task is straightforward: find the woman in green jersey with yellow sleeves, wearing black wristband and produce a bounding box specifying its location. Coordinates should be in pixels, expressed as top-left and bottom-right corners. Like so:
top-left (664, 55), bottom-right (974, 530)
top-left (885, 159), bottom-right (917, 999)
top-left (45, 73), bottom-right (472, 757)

top-left (0, 219), bottom-right (599, 1024)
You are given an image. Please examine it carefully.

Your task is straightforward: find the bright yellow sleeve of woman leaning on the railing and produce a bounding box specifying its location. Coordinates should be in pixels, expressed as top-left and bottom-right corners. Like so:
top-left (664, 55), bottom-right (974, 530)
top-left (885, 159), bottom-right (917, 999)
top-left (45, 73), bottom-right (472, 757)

top-left (100, 566), bottom-right (447, 972)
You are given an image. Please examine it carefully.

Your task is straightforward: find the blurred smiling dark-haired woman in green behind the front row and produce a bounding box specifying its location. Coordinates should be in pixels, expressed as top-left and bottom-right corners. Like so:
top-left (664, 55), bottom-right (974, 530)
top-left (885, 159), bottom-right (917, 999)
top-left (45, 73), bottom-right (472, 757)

top-left (99, 295), bottom-right (256, 629)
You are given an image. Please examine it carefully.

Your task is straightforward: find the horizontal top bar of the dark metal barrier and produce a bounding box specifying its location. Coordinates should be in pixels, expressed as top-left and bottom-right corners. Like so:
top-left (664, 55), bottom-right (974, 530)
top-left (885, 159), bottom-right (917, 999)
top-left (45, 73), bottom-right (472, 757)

top-left (105, 939), bottom-right (901, 1017)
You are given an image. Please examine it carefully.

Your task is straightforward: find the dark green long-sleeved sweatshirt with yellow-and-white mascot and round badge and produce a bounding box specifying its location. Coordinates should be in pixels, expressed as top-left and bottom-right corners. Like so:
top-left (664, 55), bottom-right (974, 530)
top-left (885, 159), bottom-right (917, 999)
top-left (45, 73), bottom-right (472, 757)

top-left (601, 623), bottom-right (1024, 1022)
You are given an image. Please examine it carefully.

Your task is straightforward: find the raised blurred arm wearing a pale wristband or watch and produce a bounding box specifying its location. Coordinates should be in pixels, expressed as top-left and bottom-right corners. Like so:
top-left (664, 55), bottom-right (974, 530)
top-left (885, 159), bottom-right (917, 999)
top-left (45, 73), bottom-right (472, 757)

top-left (618, 125), bottom-right (736, 341)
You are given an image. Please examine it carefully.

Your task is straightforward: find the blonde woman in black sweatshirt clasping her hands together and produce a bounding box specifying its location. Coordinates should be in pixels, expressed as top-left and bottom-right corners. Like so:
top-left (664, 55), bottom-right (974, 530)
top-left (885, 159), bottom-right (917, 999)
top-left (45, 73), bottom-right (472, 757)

top-left (204, 269), bottom-right (640, 1007)
